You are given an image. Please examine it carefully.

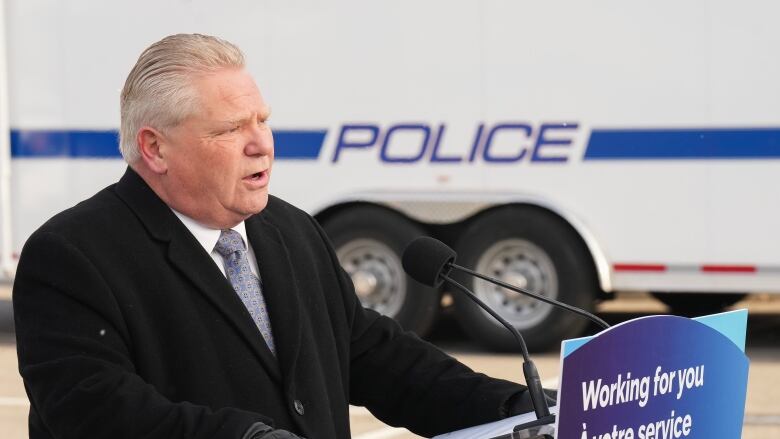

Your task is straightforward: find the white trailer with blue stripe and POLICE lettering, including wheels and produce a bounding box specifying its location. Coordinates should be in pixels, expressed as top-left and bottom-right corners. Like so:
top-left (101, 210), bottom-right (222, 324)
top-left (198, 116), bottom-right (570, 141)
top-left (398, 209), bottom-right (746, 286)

top-left (0, 0), bottom-right (780, 349)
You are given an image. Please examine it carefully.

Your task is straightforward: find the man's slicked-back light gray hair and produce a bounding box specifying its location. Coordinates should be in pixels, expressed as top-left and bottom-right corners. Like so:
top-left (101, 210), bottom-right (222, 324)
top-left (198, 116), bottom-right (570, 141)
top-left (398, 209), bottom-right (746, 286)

top-left (119, 34), bottom-right (244, 164)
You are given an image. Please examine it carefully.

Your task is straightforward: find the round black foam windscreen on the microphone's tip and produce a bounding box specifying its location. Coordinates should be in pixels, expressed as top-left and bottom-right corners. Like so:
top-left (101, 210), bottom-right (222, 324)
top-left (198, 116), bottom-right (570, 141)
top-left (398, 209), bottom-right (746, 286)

top-left (401, 236), bottom-right (455, 287)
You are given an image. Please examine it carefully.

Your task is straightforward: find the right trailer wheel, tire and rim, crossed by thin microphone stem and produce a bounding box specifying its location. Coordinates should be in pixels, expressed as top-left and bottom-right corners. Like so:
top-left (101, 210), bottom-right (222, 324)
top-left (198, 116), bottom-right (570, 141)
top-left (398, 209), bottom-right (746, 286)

top-left (454, 206), bottom-right (599, 352)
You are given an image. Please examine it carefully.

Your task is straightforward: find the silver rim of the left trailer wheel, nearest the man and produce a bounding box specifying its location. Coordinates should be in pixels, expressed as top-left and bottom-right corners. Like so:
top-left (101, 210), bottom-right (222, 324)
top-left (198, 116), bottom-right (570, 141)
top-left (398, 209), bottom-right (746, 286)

top-left (336, 239), bottom-right (406, 317)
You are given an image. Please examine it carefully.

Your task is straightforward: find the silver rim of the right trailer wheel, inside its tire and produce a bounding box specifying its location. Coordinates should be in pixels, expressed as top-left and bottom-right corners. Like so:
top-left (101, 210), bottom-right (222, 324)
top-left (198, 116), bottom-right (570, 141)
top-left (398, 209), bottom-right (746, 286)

top-left (474, 239), bottom-right (558, 330)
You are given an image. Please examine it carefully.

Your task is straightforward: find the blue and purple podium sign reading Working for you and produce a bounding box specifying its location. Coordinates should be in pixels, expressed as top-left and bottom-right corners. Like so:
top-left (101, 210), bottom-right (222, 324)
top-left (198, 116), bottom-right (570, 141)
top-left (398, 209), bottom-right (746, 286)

top-left (556, 310), bottom-right (748, 439)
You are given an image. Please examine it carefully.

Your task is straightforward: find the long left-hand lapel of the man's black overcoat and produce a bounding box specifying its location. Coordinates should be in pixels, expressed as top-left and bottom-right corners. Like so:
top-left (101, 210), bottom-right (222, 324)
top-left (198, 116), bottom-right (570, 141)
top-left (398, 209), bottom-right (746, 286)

top-left (117, 168), bottom-right (282, 382)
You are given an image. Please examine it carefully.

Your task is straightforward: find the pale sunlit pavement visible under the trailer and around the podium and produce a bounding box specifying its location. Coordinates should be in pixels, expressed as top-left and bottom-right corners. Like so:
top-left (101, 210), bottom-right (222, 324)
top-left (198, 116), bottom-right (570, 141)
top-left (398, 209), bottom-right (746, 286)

top-left (0, 286), bottom-right (780, 439)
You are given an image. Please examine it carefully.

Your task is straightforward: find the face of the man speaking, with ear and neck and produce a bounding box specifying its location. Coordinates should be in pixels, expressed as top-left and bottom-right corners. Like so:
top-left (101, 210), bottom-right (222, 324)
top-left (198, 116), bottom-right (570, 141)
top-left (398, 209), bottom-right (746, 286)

top-left (160, 69), bottom-right (274, 228)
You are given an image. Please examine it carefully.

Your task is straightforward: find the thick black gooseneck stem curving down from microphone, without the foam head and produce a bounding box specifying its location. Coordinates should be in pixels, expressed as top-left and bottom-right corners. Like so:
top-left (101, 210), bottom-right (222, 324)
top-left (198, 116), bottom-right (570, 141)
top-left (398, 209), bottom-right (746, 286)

top-left (439, 276), bottom-right (555, 432)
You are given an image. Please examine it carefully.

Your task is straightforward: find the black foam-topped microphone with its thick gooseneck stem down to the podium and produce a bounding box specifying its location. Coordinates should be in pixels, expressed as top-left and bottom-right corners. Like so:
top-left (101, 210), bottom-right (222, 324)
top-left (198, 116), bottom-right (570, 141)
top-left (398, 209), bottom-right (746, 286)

top-left (401, 236), bottom-right (555, 425)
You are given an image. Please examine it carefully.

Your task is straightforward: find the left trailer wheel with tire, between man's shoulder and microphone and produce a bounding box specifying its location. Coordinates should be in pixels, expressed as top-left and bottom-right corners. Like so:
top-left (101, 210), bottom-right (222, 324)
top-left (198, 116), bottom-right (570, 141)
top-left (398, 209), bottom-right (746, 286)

top-left (316, 206), bottom-right (440, 337)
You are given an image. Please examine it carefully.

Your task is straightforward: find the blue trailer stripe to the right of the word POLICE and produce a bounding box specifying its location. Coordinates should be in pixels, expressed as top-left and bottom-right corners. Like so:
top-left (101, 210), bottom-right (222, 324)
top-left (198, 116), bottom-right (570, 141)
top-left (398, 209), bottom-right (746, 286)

top-left (584, 128), bottom-right (780, 160)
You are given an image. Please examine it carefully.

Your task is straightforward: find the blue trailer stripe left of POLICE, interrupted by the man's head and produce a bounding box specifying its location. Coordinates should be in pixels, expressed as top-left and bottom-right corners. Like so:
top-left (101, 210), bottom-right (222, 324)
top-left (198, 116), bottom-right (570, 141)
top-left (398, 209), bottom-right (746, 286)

top-left (11, 130), bottom-right (327, 160)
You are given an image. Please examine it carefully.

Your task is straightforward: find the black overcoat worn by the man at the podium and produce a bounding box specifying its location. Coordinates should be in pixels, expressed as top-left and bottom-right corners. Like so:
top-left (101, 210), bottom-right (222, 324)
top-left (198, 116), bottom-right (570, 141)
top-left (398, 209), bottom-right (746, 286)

top-left (13, 169), bottom-right (524, 439)
